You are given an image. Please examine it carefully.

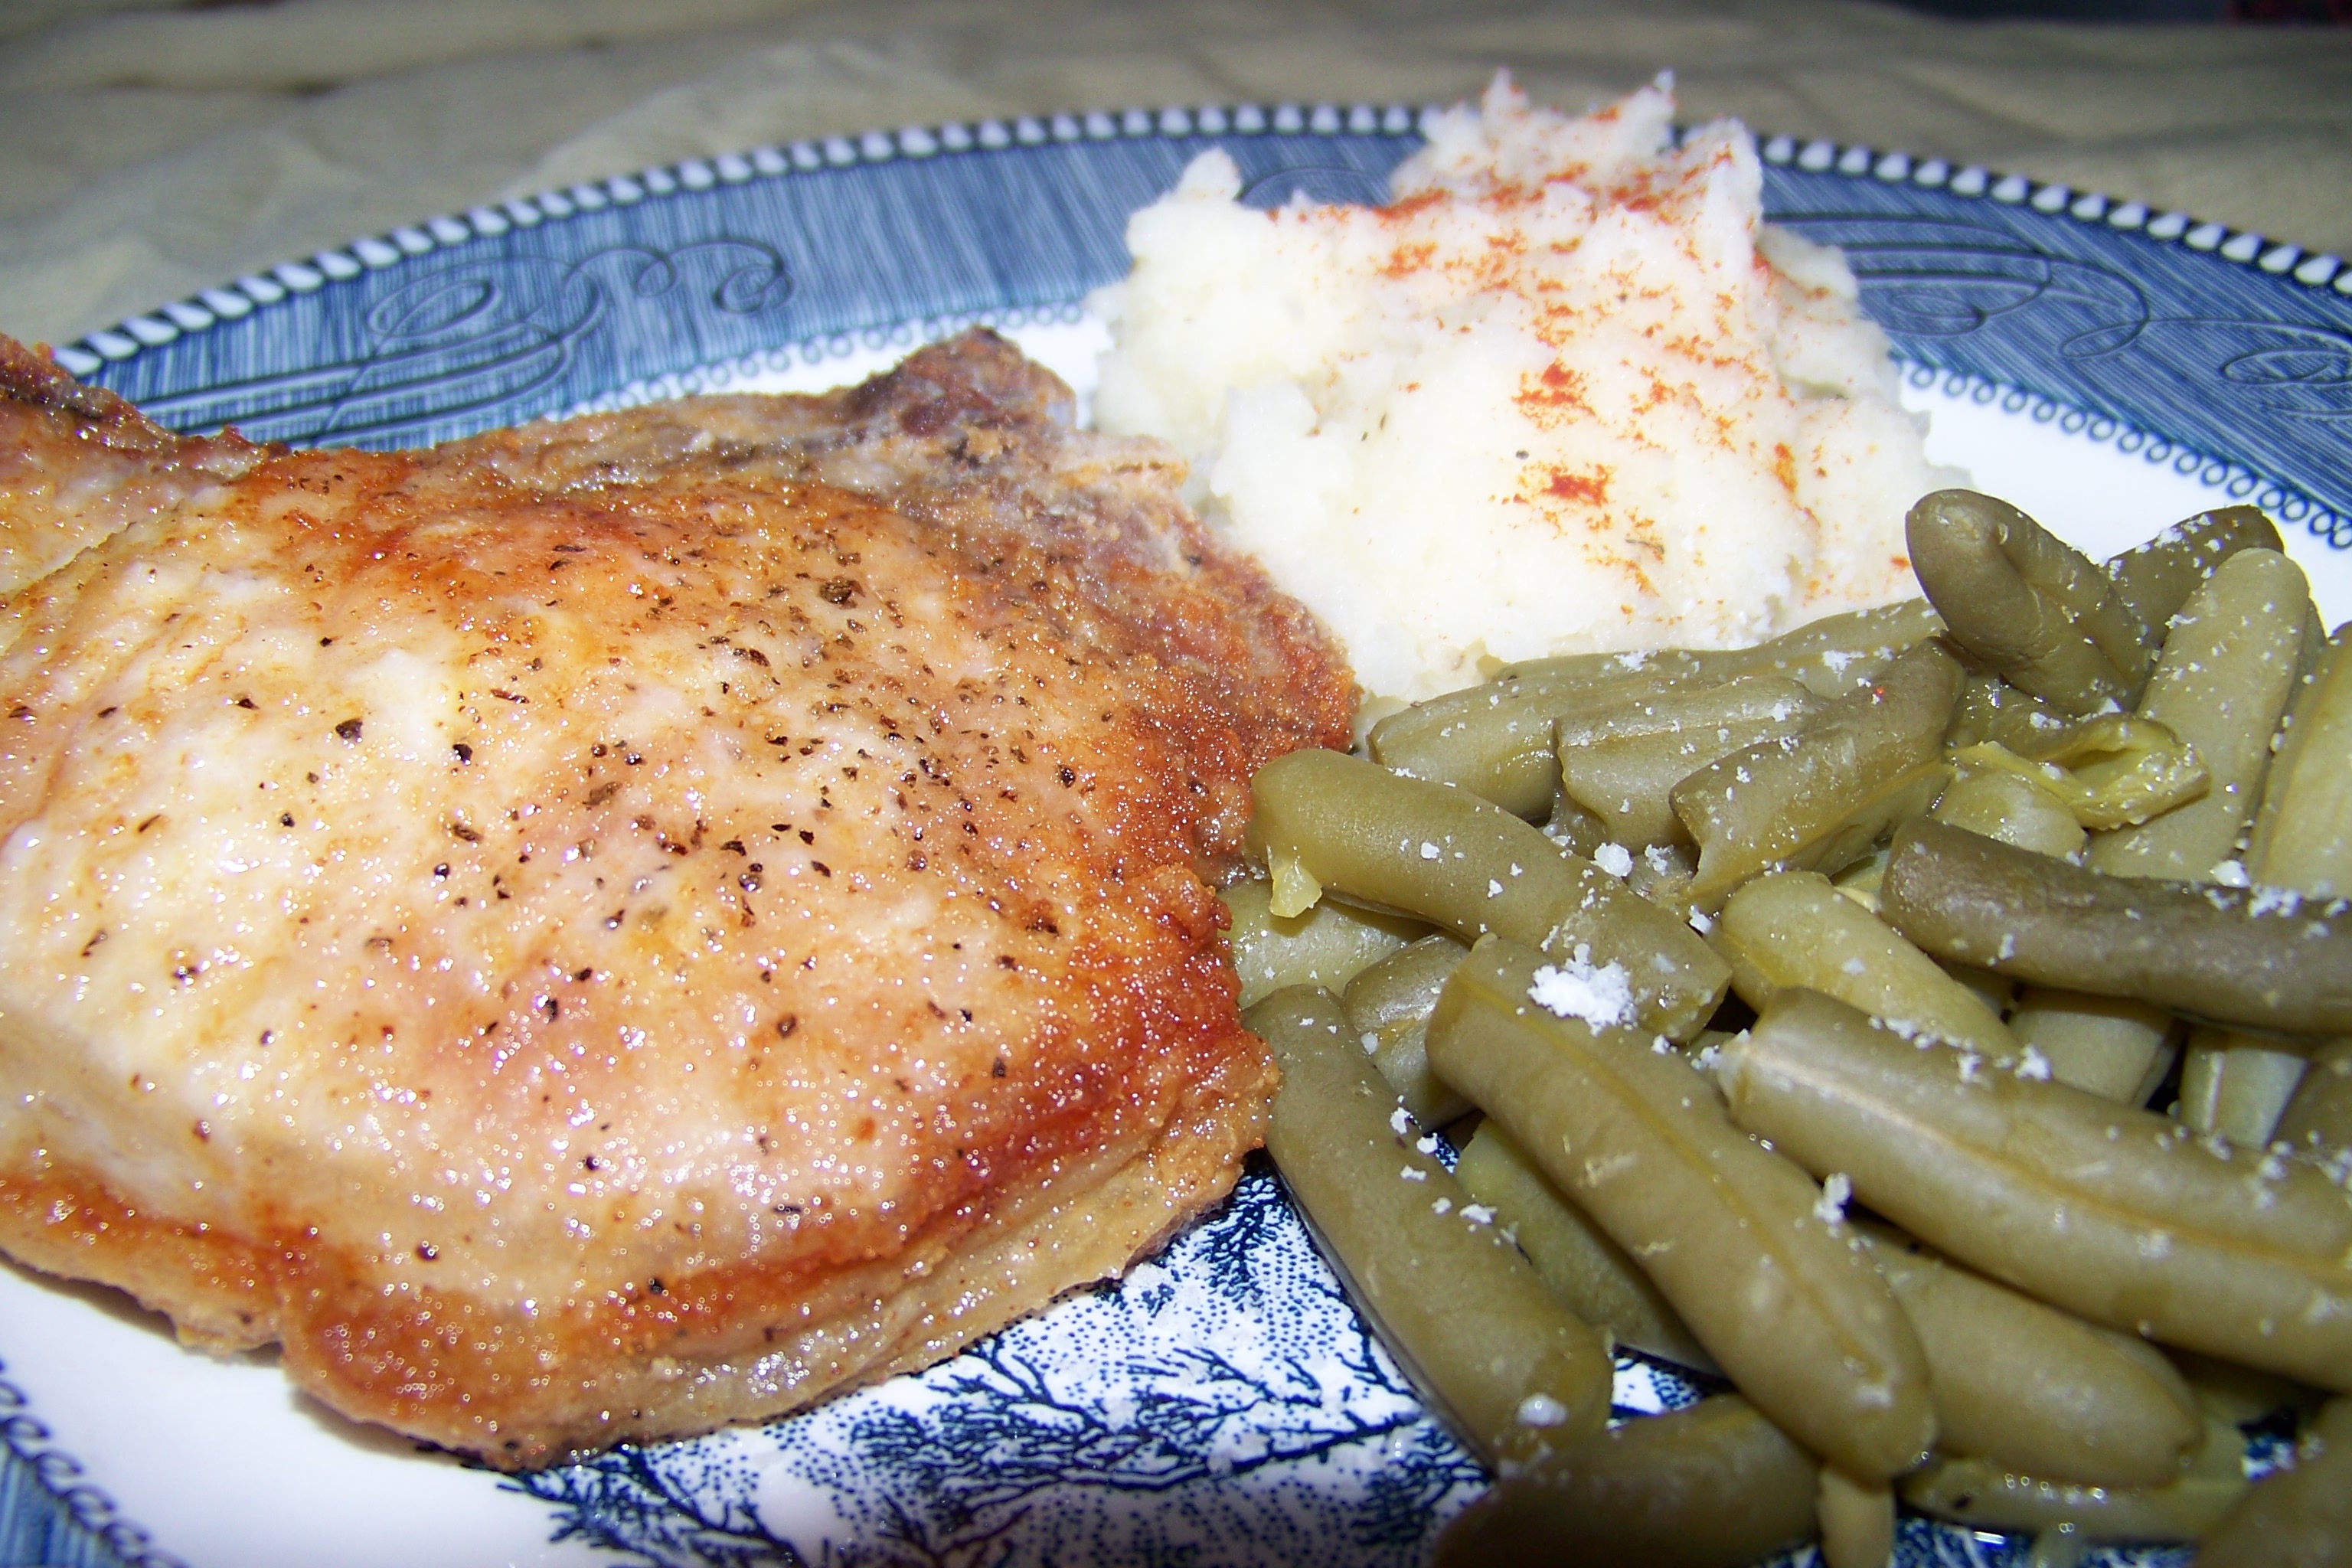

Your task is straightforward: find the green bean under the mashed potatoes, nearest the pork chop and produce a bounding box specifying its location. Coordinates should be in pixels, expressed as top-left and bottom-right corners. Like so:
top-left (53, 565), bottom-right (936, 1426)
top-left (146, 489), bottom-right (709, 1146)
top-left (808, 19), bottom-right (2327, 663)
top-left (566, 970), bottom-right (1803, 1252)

top-left (1367, 648), bottom-right (1703, 818)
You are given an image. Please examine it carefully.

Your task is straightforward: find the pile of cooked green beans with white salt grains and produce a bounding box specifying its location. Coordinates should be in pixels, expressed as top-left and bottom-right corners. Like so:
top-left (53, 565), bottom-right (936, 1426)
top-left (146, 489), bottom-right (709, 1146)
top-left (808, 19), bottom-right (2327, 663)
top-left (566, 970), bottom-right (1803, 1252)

top-left (1228, 492), bottom-right (2352, 1568)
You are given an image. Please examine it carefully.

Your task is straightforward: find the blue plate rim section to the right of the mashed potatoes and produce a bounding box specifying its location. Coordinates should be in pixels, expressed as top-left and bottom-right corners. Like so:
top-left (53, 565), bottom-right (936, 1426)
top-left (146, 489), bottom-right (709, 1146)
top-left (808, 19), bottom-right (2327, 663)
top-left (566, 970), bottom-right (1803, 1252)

top-left (1759, 136), bottom-right (2352, 550)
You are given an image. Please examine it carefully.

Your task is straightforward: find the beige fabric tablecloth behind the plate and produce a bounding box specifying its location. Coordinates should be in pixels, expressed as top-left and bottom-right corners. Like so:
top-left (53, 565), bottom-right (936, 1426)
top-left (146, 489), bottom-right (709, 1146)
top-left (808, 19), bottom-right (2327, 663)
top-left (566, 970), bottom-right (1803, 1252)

top-left (0, 0), bottom-right (2352, 341)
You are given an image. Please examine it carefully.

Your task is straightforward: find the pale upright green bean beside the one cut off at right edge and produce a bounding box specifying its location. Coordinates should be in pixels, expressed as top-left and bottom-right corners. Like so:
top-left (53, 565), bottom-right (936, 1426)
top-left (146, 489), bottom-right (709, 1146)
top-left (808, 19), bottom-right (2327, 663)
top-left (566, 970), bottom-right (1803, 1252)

top-left (2091, 550), bottom-right (2312, 881)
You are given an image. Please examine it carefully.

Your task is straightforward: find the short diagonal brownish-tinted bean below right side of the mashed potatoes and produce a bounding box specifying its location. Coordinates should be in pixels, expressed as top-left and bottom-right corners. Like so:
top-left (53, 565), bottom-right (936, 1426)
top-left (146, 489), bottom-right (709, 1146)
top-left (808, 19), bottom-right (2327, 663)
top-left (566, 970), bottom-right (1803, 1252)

top-left (1672, 642), bottom-right (1959, 910)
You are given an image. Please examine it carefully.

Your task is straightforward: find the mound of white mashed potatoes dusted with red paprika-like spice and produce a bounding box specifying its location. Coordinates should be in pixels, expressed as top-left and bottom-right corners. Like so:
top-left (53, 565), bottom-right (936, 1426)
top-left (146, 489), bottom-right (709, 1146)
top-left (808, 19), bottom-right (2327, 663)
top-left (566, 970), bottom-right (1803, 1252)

top-left (1093, 77), bottom-right (1955, 701)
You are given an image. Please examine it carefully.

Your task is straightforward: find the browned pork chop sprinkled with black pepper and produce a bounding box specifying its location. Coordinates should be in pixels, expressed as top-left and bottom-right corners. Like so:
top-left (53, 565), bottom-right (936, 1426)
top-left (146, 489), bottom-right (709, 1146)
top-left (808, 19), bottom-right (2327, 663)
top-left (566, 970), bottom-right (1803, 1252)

top-left (0, 334), bottom-right (1354, 1467)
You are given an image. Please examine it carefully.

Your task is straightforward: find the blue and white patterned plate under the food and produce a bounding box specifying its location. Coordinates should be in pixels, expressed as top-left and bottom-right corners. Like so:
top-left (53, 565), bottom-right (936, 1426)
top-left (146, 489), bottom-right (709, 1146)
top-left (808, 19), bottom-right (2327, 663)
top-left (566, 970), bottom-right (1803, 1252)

top-left (0, 106), bottom-right (2352, 1568)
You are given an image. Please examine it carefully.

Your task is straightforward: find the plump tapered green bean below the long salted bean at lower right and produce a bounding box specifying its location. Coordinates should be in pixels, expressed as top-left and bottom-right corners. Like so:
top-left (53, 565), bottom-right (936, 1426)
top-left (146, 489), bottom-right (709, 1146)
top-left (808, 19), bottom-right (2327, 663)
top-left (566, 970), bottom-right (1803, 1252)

top-left (1856, 1223), bottom-right (2203, 1486)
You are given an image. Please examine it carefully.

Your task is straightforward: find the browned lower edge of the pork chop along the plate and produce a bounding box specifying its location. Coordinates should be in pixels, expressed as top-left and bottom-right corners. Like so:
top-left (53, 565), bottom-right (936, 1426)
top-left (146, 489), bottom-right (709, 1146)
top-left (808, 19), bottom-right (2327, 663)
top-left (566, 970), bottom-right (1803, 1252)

top-left (0, 1044), bottom-right (1275, 1467)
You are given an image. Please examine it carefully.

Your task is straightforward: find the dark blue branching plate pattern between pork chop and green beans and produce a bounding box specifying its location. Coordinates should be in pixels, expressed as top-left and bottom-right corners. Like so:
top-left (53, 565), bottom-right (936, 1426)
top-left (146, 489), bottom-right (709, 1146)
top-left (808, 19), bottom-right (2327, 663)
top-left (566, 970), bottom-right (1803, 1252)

top-left (508, 1171), bottom-right (1484, 1568)
